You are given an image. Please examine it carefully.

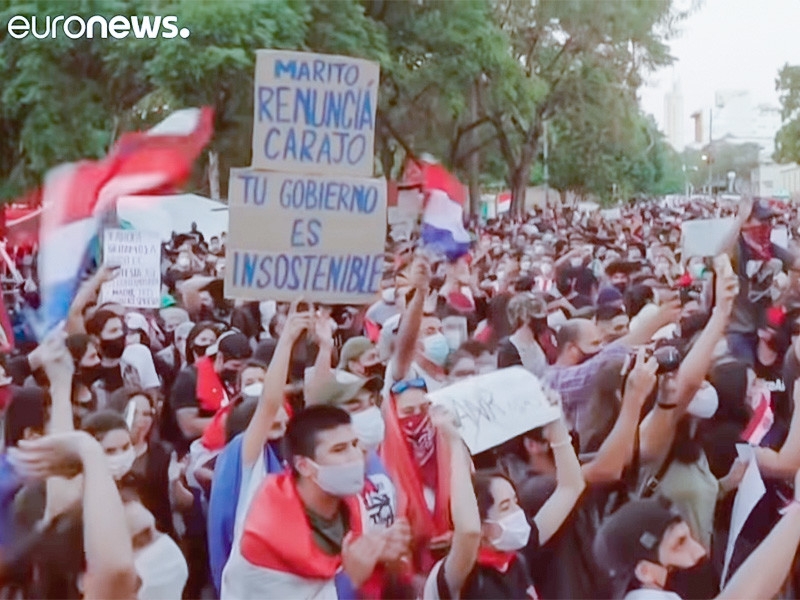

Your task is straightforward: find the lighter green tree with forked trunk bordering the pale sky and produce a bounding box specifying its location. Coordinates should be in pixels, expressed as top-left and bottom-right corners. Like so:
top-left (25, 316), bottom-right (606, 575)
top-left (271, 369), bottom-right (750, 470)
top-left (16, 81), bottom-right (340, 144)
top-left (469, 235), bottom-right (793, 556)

top-left (484, 0), bottom-right (684, 211)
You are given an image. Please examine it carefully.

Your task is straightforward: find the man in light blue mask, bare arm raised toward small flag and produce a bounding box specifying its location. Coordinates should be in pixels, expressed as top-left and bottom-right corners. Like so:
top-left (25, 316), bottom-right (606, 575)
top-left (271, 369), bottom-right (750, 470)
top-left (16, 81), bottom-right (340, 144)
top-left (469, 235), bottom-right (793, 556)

top-left (383, 257), bottom-right (450, 396)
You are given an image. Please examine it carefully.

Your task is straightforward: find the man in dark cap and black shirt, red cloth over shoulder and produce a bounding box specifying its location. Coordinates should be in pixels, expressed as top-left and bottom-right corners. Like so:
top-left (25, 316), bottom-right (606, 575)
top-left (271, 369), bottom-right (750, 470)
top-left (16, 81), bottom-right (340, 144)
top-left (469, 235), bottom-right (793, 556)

top-left (170, 330), bottom-right (252, 452)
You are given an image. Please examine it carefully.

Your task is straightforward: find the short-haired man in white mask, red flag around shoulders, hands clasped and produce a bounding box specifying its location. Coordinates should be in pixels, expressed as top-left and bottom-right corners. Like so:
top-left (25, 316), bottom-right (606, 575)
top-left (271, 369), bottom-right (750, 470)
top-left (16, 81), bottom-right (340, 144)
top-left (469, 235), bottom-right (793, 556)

top-left (221, 406), bottom-right (408, 600)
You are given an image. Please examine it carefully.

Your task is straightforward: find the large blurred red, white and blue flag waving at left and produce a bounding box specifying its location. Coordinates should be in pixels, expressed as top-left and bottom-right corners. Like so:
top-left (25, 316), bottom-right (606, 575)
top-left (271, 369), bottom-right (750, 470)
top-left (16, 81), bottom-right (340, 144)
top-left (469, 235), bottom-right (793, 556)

top-left (39, 108), bottom-right (213, 331)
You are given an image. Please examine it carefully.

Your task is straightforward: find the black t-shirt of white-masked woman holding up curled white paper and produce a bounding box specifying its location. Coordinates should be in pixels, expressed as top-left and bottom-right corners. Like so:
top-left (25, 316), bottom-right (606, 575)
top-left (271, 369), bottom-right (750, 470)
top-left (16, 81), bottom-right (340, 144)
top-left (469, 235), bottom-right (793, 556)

top-left (435, 521), bottom-right (539, 600)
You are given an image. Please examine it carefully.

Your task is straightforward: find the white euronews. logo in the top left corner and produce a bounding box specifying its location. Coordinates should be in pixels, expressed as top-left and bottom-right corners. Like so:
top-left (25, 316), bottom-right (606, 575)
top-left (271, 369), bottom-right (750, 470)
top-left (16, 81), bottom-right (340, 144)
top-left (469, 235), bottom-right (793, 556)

top-left (8, 15), bottom-right (191, 40)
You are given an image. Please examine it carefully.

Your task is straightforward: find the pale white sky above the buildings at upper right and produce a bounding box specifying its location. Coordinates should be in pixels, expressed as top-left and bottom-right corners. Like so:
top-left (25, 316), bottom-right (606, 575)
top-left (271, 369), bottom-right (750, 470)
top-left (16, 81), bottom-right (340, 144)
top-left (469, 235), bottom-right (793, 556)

top-left (640, 0), bottom-right (800, 143)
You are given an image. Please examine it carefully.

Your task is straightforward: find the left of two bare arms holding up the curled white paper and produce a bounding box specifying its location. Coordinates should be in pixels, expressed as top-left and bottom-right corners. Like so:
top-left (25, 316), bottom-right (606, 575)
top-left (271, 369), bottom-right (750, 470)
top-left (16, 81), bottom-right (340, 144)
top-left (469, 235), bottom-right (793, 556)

top-left (431, 409), bottom-right (481, 598)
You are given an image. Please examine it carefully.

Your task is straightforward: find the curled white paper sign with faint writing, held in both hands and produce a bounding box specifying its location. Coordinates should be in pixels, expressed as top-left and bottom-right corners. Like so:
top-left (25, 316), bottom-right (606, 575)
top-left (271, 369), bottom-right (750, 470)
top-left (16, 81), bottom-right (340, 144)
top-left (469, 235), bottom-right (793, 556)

top-left (428, 367), bottom-right (561, 455)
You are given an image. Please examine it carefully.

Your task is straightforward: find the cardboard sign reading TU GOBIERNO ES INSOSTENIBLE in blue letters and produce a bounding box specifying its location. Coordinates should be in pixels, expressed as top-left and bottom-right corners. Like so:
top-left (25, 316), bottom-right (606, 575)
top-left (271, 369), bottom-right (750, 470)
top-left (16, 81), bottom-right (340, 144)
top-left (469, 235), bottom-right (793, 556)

top-left (225, 169), bottom-right (386, 304)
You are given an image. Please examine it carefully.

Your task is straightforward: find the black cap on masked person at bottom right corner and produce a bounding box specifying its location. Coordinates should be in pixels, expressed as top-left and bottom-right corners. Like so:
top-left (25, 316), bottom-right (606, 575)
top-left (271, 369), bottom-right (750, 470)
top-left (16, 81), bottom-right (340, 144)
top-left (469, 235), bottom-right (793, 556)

top-left (593, 497), bottom-right (682, 581)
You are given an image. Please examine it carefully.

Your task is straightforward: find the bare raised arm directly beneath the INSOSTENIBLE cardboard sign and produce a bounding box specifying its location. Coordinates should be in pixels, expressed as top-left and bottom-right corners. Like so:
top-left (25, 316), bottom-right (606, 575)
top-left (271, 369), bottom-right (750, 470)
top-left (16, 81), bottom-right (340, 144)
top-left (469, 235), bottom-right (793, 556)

top-left (242, 301), bottom-right (313, 466)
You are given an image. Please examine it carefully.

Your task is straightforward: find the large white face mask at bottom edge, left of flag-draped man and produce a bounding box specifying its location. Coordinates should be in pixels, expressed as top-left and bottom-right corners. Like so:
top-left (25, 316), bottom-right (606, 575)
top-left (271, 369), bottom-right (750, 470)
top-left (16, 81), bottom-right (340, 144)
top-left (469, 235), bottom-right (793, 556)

top-left (133, 534), bottom-right (189, 600)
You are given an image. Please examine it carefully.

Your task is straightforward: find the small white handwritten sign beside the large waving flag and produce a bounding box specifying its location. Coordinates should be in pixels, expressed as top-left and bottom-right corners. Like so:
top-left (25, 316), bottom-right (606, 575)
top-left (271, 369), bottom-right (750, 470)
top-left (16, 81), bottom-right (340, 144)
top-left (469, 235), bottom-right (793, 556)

top-left (100, 229), bottom-right (161, 308)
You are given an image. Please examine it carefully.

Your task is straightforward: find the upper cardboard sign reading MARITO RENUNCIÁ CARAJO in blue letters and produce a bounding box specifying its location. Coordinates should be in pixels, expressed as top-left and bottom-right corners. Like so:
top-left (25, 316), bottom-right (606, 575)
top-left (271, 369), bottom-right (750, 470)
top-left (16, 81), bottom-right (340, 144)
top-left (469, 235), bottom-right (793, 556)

top-left (253, 50), bottom-right (380, 177)
